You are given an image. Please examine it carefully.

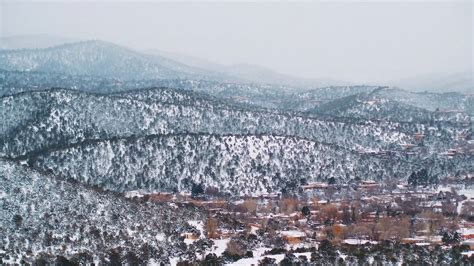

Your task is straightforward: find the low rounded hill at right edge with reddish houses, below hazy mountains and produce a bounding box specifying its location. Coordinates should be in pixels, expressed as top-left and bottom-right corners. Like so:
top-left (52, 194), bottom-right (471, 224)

top-left (307, 90), bottom-right (470, 124)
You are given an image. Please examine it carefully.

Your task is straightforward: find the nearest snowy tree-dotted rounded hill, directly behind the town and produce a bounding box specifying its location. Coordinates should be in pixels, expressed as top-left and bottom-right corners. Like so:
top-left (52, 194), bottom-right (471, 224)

top-left (24, 134), bottom-right (474, 195)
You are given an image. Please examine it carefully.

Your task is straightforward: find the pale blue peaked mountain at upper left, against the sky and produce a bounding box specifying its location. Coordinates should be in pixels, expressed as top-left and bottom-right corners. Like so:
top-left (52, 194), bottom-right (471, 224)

top-left (0, 41), bottom-right (237, 80)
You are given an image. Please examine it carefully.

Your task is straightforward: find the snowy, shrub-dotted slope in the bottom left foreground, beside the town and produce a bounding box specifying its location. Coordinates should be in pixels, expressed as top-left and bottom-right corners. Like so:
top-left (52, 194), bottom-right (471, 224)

top-left (0, 160), bottom-right (202, 264)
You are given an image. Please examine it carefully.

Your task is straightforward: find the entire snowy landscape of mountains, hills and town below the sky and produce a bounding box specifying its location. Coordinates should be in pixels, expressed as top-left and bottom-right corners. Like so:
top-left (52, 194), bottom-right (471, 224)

top-left (0, 41), bottom-right (474, 265)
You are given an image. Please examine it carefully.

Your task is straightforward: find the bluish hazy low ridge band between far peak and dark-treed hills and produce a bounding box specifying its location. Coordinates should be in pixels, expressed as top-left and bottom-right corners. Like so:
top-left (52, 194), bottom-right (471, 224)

top-left (0, 70), bottom-right (474, 116)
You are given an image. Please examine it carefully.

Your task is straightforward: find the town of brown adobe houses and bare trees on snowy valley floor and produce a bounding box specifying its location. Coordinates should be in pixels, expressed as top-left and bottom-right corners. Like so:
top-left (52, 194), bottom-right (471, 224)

top-left (127, 176), bottom-right (474, 265)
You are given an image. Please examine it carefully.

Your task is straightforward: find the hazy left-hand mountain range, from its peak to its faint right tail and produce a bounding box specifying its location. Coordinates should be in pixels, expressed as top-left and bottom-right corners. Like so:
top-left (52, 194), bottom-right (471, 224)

top-left (0, 39), bottom-right (334, 87)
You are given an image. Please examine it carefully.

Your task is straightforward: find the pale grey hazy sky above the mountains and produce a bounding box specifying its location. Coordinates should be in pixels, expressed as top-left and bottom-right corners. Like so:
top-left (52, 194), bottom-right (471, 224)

top-left (0, 0), bottom-right (474, 83)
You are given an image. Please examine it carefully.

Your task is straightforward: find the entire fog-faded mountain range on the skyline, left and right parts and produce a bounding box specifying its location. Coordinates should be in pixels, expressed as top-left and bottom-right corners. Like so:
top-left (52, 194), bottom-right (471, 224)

top-left (0, 35), bottom-right (474, 93)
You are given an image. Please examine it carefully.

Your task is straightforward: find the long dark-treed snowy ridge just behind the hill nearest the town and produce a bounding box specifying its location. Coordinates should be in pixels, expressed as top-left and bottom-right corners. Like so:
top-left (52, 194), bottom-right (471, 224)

top-left (0, 88), bottom-right (468, 158)
